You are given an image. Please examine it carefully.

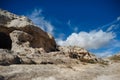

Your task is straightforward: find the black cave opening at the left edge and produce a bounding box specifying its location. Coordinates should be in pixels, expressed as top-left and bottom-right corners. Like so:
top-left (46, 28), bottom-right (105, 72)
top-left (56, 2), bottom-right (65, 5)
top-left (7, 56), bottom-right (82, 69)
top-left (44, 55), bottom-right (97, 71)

top-left (0, 32), bottom-right (12, 50)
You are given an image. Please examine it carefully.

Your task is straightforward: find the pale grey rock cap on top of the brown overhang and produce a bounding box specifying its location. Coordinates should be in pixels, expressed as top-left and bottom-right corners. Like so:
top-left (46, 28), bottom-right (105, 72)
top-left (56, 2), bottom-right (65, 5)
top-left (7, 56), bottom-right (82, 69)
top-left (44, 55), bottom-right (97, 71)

top-left (0, 9), bottom-right (33, 27)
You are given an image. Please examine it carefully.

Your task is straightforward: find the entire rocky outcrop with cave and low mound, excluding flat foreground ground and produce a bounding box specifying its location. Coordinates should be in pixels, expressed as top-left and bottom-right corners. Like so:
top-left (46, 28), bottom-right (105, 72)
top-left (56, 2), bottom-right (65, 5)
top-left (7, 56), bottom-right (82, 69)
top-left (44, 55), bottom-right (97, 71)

top-left (0, 9), bottom-right (97, 65)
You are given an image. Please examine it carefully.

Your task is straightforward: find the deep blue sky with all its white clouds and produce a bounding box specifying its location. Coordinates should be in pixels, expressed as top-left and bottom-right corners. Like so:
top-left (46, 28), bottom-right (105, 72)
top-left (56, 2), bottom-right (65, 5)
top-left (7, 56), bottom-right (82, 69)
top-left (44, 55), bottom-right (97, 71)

top-left (0, 0), bottom-right (120, 56)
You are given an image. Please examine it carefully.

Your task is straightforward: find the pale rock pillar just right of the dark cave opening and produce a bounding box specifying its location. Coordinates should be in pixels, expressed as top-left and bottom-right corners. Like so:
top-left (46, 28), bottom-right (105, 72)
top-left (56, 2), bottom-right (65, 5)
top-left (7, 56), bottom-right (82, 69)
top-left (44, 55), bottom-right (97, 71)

top-left (10, 30), bottom-right (33, 53)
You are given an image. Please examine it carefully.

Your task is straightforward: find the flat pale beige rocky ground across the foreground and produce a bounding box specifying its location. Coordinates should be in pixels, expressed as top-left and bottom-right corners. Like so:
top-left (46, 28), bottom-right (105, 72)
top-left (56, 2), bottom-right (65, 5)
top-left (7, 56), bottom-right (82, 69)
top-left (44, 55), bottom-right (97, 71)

top-left (0, 62), bottom-right (120, 80)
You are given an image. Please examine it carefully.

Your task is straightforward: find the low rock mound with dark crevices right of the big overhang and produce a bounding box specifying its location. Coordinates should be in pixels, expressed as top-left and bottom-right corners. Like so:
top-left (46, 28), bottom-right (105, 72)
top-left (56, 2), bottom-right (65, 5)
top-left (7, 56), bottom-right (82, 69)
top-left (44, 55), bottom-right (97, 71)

top-left (58, 46), bottom-right (98, 63)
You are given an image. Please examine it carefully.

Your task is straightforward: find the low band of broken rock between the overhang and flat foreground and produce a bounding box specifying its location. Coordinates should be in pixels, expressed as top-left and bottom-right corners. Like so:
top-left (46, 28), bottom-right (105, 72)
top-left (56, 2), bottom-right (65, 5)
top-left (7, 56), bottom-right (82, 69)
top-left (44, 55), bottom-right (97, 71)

top-left (0, 46), bottom-right (98, 65)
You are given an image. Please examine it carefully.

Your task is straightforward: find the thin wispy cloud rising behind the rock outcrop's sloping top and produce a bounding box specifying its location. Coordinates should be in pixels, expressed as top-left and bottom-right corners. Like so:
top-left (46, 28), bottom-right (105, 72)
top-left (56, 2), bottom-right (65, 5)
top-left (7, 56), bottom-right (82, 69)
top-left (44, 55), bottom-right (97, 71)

top-left (27, 9), bottom-right (54, 35)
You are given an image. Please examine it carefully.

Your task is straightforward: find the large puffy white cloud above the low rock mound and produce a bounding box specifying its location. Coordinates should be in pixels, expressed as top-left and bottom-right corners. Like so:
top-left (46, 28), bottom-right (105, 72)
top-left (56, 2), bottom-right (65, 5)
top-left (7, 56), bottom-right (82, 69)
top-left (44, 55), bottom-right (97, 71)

top-left (57, 30), bottom-right (115, 49)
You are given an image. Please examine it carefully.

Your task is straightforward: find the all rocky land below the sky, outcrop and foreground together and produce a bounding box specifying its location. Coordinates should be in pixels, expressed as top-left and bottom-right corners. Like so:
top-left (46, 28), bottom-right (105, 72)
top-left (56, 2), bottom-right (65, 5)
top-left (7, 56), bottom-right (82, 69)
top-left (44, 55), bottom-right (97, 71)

top-left (0, 9), bottom-right (120, 80)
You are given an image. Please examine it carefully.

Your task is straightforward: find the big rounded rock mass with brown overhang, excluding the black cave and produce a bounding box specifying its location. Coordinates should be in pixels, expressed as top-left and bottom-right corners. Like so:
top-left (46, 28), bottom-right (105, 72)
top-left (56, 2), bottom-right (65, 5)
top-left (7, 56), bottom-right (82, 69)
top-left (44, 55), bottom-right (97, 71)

top-left (0, 9), bottom-right (56, 52)
